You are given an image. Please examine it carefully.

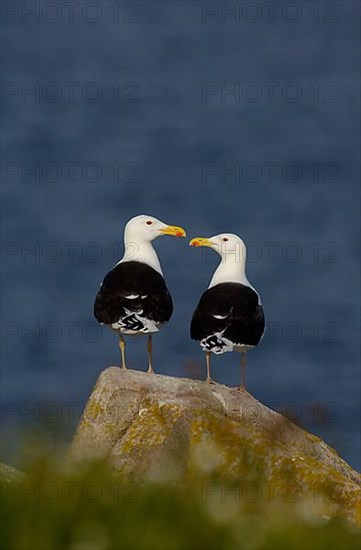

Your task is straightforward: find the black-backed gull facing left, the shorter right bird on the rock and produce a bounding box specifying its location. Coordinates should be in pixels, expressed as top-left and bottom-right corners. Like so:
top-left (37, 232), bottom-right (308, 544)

top-left (189, 233), bottom-right (265, 390)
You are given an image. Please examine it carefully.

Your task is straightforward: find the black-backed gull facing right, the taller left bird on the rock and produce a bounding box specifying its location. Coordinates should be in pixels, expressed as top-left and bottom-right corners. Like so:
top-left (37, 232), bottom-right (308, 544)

top-left (94, 214), bottom-right (186, 373)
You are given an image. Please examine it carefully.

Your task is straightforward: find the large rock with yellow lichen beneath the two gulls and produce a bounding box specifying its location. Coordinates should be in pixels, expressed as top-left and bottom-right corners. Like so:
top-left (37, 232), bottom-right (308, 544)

top-left (68, 367), bottom-right (360, 521)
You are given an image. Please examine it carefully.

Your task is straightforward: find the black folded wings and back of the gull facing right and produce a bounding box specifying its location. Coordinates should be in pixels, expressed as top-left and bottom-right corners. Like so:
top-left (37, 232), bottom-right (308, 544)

top-left (94, 262), bottom-right (173, 330)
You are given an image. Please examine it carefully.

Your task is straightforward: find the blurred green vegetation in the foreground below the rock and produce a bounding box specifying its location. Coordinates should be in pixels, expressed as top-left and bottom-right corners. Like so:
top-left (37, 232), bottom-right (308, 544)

top-left (1, 454), bottom-right (360, 550)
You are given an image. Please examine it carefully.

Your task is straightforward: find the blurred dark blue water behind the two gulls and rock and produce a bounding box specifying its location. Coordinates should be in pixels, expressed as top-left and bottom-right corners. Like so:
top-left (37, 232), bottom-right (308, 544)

top-left (2, 1), bottom-right (360, 467)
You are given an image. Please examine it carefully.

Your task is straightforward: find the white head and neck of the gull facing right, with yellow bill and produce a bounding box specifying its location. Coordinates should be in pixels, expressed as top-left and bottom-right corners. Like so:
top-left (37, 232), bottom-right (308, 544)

top-left (119, 214), bottom-right (186, 274)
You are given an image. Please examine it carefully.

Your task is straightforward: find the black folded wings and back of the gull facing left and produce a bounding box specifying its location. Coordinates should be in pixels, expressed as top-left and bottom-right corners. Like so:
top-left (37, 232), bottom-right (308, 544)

top-left (190, 283), bottom-right (265, 346)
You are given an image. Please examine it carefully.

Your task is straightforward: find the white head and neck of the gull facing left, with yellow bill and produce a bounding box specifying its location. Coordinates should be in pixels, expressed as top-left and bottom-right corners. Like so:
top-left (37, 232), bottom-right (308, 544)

top-left (189, 233), bottom-right (253, 288)
